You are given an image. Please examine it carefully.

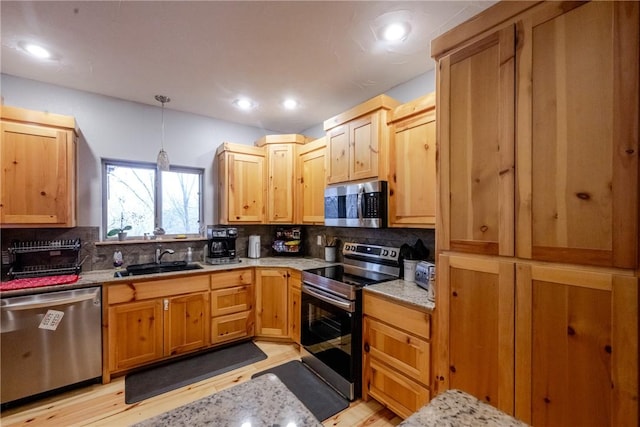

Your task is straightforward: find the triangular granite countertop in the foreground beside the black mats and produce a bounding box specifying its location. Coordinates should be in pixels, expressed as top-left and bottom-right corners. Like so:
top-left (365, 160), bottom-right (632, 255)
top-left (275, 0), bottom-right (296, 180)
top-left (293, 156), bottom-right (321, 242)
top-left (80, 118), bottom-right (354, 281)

top-left (135, 374), bottom-right (322, 427)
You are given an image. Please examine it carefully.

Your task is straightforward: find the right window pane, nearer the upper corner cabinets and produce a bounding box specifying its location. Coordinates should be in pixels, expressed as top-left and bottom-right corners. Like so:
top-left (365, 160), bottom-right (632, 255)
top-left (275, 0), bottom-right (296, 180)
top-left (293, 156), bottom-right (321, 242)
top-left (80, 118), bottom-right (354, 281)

top-left (162, 171), bottom-right (201, 234)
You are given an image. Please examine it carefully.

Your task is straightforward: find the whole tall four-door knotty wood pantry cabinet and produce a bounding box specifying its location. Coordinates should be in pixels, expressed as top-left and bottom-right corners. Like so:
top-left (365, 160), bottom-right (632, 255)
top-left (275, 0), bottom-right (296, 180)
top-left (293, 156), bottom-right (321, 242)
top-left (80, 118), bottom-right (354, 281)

top-left (432, 2), bottom-right (640, 426)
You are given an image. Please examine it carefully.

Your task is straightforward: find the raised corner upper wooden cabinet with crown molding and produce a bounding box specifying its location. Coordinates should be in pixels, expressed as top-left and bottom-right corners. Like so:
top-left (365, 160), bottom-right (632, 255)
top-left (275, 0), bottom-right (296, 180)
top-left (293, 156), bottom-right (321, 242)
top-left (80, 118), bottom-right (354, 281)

top-left (256, 134), bottom-right (309, 224)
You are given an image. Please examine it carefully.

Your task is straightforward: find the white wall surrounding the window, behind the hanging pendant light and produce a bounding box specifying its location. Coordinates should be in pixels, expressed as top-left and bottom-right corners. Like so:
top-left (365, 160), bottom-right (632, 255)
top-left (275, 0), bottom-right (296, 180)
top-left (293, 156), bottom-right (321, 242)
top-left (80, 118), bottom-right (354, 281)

top-left (0, 74), bottom-right (275, 226)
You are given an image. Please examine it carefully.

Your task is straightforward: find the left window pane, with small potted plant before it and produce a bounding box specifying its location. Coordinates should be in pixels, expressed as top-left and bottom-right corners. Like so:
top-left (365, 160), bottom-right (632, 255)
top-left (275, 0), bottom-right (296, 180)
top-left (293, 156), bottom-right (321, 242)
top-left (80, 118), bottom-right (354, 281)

top-left (106, 164), bottom-right (155, 237)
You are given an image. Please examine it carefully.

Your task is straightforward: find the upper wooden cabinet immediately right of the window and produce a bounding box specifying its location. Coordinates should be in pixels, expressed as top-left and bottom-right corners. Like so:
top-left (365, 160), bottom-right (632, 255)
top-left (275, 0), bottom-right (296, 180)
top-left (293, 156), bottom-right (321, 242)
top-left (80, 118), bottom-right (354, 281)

top-left (216, 142), bottom-right (266, 224)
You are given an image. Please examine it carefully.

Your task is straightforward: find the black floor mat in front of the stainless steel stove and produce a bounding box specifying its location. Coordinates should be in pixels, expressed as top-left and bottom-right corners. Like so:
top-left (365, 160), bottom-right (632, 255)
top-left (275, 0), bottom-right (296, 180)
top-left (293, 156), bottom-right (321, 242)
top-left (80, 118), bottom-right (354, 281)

top-left (251, 361), bottom-right (349, 421)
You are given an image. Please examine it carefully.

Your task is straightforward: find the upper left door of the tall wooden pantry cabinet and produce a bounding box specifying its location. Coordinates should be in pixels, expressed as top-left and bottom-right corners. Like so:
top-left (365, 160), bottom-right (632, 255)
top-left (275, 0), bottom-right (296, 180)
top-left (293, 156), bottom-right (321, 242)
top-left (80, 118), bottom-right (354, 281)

top-left (437, 26), bottom-right (515, 256)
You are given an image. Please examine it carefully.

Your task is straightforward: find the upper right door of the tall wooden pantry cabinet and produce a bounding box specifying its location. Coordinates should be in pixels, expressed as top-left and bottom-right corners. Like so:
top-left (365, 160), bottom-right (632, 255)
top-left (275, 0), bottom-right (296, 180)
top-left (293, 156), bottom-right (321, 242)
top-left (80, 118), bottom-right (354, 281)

top-left (518, 2), bottom-right (640, 268)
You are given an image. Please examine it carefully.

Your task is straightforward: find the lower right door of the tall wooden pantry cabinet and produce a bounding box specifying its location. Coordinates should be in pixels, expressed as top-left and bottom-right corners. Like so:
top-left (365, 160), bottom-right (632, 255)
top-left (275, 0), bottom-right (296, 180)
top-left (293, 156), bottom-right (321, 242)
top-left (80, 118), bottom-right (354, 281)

top-left (515, 265), bottom-right (639, 426)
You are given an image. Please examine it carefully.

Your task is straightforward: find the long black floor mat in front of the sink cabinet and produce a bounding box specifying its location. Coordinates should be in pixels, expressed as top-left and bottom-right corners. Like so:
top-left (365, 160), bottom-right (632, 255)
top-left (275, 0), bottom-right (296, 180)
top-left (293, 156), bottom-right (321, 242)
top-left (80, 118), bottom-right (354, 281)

top-left (124, 341), bottom-right (267, 403)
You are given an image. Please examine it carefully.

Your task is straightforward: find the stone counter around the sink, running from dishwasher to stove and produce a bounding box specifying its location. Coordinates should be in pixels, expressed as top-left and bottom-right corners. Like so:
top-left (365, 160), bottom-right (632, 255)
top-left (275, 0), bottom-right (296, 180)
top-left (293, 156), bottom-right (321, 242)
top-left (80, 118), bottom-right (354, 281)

top-left (0, 257), bottom-right (336, 298)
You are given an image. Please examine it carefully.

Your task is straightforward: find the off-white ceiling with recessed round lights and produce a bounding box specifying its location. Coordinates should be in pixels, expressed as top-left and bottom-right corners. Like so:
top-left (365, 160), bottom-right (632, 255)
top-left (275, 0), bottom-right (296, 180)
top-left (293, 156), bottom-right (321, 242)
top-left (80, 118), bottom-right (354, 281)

top-left (0, 0), bottom-right (494, 133)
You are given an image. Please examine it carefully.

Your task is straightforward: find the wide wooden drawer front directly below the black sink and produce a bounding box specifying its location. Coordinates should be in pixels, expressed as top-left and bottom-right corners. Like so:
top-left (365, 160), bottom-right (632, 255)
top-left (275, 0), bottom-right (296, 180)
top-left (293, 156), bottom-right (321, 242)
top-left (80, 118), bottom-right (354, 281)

top-left (107, 274), bottom-right (209, 304)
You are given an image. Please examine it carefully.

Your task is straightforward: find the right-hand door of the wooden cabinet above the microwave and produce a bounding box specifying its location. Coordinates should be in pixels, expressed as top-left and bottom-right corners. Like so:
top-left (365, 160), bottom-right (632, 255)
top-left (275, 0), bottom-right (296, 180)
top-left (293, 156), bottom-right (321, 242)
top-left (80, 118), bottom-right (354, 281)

top-left (349, 113), bottom-right (386, 181)
